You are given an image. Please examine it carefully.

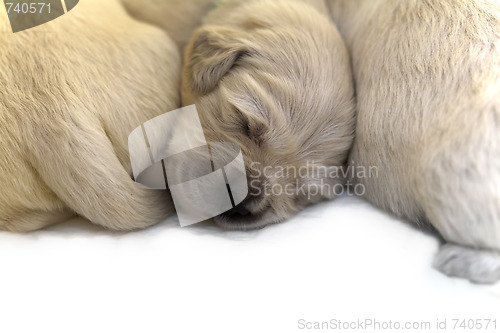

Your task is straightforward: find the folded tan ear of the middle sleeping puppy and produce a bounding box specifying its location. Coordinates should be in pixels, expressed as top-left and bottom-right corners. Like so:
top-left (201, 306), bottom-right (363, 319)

top-left (184, 26), bottom-right (254, 94)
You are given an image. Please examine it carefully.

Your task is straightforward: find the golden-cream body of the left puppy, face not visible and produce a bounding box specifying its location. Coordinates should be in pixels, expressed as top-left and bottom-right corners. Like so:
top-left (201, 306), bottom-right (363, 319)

top-left (0, 0), bottom-right (181, 231)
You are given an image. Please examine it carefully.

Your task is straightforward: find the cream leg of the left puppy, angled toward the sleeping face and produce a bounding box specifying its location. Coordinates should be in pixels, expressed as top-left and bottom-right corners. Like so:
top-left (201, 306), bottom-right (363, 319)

top-left (25, 116), bottom-right (174, 230)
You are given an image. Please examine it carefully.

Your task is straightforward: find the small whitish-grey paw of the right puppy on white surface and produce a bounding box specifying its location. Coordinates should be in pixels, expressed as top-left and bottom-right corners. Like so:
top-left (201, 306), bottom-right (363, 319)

top-left (433, 244), bottom-right (500, 284)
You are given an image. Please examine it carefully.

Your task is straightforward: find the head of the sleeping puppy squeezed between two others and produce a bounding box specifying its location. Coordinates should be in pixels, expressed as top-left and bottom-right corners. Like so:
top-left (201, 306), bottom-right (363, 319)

top-left (182, 0), bottom-right (355, 229)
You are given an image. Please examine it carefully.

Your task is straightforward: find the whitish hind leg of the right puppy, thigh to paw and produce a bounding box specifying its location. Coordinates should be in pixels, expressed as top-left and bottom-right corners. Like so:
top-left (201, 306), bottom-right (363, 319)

top-left (416, 115), bottom-right (500, 283)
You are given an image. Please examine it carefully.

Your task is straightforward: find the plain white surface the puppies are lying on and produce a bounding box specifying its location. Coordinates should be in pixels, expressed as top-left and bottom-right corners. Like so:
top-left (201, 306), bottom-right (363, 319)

top-left (0, 197), bottom-right (500, 333)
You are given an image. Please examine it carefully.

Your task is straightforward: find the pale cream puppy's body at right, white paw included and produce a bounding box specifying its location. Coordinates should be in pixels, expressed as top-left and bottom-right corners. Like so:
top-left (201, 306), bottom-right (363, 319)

top-left (329, 0), bottom-right (500, 283)
